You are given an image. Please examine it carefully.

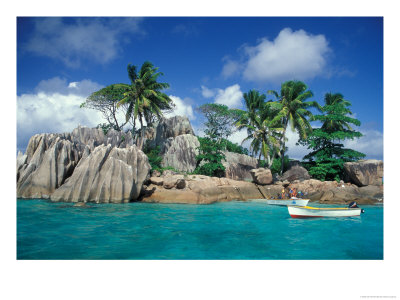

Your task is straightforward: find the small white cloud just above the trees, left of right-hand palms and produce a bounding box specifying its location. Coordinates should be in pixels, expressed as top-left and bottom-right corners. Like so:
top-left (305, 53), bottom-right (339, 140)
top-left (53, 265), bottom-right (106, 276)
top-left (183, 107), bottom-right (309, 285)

top-left (201, 84), bottom-right (243, 108)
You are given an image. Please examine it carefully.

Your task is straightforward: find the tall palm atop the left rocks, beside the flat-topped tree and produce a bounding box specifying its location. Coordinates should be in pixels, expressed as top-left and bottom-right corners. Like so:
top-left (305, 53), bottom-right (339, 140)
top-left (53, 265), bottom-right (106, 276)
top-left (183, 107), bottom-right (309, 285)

top-left (119, 61), bottom-right (174, 149)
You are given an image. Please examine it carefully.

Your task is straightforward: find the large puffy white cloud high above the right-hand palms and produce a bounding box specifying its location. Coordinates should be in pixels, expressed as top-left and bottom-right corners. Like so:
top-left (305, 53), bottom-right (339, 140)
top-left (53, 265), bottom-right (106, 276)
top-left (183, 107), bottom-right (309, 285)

top-left (222, 28), bottom-right (331, 82)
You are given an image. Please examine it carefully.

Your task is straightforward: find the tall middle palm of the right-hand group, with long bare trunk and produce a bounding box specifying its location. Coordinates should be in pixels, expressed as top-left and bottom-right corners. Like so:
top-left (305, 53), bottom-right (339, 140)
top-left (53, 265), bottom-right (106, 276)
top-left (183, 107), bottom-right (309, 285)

top-left (267, 81), bottom-right (321, 174)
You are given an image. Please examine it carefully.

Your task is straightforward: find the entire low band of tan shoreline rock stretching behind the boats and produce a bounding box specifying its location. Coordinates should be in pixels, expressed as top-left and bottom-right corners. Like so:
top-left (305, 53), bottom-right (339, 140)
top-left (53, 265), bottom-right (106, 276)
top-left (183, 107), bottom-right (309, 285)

top-left (140, 175), bottom-right (383, 205)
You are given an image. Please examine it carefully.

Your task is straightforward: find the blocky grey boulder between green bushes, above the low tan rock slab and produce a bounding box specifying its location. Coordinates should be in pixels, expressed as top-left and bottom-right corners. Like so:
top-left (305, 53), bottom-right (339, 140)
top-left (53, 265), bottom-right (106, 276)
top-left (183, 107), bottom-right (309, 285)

top-left (161, 134), bottom-right (200, 172)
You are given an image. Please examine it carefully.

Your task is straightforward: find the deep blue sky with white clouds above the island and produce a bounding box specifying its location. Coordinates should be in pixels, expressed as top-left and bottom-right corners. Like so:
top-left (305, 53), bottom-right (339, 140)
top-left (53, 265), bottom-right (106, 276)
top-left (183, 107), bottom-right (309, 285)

top-left (17, 17), bottom-right (383, 159)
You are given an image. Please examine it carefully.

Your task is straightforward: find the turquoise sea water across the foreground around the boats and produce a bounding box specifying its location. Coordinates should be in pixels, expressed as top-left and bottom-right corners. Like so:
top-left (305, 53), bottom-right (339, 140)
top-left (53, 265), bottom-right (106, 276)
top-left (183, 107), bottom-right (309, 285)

top-left (17, 200), bottom-right (383, 260)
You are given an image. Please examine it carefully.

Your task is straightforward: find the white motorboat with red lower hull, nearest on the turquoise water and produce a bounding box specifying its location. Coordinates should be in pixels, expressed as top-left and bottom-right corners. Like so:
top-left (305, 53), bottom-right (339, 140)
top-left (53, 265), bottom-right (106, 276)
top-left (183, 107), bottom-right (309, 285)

top-left (288, 202), bottom-right (364, 218)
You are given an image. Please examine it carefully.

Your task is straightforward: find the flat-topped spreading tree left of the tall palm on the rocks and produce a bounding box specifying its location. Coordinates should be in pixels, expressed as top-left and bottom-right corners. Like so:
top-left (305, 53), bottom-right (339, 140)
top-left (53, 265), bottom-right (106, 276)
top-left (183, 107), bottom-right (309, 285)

top-left (80, 83), bottom-right (128, 131)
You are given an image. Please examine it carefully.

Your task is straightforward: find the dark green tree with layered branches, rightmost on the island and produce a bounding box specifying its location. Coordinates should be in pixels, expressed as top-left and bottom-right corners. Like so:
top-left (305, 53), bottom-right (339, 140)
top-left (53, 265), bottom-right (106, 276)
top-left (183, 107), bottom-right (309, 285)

top-left (299, 93), bottom-right (365, 181)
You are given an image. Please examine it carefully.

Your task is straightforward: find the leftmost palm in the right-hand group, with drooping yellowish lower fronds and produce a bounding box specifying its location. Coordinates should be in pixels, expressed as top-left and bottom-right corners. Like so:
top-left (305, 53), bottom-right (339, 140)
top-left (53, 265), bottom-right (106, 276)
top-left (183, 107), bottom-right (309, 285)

top-left (236, 90), bottom-right (282, 168)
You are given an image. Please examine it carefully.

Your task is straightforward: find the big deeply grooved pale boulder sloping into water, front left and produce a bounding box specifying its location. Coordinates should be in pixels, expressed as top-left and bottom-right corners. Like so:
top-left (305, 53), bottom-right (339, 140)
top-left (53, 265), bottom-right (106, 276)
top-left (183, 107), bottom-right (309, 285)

top-left (50, 145), bottom-right (150, 203)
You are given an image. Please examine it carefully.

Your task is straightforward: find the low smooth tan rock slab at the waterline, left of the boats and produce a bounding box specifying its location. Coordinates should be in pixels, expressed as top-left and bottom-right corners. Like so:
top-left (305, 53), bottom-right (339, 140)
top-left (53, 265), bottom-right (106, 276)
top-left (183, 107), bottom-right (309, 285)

top-left (141, 175), bottom-right (263, 204)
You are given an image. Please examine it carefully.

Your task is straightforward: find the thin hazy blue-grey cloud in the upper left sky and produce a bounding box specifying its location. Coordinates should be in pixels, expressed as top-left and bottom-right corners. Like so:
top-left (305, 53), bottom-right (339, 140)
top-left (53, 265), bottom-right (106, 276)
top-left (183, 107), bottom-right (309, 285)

top-left (22, 18), bottom-right (143, 67)
